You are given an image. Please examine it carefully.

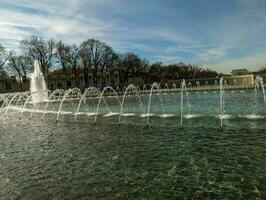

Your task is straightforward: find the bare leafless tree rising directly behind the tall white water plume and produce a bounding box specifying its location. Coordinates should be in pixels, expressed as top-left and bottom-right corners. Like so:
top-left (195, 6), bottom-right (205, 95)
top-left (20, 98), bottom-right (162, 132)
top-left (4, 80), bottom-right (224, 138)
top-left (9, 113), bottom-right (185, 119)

top-left (20, 36), bottom-right (56, 77)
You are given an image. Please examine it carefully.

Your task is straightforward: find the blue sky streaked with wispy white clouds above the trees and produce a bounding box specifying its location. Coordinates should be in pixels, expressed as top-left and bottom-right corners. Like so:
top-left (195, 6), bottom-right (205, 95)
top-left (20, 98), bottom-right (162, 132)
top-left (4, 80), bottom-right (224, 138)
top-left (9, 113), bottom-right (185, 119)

top-left (0, 0), bottom-right (266, 72)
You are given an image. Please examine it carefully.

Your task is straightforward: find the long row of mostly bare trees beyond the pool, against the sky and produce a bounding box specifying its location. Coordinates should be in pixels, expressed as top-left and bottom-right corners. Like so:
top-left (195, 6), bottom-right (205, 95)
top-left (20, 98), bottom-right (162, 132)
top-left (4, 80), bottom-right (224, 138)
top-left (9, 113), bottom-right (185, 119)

top-left (0, 36), bottom-right (218, 85)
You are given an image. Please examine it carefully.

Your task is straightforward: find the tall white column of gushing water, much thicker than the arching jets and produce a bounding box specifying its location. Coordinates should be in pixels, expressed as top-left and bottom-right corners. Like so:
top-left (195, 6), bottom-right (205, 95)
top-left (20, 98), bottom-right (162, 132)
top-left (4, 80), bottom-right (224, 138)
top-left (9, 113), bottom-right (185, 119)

top-left (30, 60), bottom-right (48, 103)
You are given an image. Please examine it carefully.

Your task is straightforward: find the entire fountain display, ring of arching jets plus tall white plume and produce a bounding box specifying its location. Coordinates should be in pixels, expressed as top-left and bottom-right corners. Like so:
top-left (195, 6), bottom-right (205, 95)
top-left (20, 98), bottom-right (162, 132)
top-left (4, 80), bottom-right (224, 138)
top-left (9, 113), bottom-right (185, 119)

top-left (0, 74), bottom-right (266, 127)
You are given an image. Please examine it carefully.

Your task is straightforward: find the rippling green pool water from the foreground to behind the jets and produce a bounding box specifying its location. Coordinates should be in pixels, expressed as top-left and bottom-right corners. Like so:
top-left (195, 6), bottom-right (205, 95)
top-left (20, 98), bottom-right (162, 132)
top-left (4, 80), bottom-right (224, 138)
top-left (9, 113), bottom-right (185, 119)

top-left (0, 91), bottom-right (266, 199)
